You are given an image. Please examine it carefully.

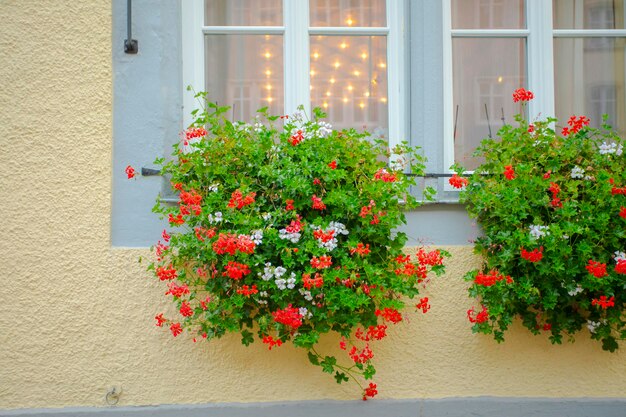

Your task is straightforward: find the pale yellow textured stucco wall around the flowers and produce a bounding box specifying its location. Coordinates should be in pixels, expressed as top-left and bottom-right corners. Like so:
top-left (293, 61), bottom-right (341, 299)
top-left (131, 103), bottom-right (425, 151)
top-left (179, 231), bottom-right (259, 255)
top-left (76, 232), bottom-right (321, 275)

top-left (0, 0), bottom-right (626, 409)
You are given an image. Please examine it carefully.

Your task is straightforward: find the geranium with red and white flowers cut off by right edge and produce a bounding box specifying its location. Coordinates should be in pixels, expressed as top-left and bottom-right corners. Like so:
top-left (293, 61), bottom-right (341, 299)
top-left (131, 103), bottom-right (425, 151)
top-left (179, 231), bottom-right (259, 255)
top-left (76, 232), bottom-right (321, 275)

top-left (457, 89), bottom-right (626, 351)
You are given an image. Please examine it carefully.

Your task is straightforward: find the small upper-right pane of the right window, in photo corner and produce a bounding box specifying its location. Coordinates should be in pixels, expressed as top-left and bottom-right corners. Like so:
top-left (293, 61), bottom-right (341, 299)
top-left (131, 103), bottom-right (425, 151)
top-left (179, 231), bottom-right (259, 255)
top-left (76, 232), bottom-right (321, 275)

top-left (552, 0), bottom-right (625, 29)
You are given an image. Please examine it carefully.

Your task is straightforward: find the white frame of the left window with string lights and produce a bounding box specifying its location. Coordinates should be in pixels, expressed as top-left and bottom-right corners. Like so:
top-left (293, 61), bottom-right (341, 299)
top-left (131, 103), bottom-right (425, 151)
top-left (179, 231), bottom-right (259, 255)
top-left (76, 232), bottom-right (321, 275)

top-left (181, 0), bottom-right (407, 147)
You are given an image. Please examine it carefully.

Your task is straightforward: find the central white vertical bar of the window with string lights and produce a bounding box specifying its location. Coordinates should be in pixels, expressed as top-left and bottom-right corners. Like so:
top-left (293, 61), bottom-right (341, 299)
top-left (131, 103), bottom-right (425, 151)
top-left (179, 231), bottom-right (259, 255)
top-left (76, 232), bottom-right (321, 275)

top-left (283, 0), bottom-right (311, 115)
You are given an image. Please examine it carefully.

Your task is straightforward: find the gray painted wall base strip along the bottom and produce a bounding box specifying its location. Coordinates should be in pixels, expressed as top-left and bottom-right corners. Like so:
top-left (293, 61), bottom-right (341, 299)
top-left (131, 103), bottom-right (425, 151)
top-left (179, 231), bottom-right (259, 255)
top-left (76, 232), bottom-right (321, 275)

top-left (0, 397), bottom-right (626, 417)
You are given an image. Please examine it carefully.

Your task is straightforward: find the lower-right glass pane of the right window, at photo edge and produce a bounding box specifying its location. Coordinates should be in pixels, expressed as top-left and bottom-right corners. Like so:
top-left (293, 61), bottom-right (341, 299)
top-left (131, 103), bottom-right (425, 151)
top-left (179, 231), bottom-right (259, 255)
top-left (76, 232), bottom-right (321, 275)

top-left (554, 38), bottom-right (626, 136)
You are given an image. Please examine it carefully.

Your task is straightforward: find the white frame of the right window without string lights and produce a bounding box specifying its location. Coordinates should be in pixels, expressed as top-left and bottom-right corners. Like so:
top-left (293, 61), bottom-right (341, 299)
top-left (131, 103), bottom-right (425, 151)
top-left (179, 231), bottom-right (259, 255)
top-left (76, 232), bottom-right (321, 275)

top-left (443, 0), bottom-right (626, 177)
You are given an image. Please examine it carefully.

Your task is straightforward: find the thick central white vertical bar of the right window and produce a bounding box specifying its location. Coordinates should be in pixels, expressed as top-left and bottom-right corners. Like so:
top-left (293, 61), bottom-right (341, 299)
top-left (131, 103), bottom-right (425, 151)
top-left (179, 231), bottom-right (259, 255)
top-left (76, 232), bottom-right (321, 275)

top-left (526, 0), bottom-right (555, 120)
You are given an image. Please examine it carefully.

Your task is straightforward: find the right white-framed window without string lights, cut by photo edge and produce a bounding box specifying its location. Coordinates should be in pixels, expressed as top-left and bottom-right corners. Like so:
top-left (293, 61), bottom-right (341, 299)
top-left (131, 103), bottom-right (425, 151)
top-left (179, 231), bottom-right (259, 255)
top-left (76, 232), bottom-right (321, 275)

top-left (443, 0), bottom-right (626, 170)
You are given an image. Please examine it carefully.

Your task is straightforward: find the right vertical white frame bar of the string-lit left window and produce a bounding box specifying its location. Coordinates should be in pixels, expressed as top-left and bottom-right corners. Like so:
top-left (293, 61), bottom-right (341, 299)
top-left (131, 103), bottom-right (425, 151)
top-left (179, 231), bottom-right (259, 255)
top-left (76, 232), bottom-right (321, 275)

top-left (387, 0), bottom-right (407, 148)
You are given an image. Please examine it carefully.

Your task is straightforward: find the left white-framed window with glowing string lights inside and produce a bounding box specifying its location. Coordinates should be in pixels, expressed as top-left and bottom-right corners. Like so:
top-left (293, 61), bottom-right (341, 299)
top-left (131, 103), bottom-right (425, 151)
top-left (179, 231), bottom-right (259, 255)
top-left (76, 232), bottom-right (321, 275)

top-left (182, 0), bottom-right (405, 144)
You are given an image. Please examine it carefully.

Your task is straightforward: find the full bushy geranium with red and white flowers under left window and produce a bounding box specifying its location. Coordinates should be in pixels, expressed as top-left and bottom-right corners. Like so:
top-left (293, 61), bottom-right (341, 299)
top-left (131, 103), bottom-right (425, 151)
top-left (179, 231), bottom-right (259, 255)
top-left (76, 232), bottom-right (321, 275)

top-left (140, 93), bottom-right (445, 399)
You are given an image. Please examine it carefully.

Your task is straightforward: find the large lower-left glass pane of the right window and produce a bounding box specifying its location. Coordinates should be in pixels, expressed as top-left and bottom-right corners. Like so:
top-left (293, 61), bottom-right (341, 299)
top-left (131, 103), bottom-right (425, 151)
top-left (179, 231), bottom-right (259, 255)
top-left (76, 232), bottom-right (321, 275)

top-left (452, 38), bottom-right (526, 170)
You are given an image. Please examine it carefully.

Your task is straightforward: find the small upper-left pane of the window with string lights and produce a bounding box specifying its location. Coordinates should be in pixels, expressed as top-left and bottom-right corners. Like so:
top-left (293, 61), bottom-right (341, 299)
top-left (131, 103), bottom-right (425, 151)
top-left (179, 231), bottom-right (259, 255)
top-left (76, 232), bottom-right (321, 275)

top-left (204, 0), bottom-right (283, 26)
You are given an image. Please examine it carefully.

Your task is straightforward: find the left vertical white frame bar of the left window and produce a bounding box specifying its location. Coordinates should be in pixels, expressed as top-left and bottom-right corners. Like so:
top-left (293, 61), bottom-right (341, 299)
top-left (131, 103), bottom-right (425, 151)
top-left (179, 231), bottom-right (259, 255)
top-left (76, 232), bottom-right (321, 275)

top-left (182, 0), bottom-right (205, 127)
